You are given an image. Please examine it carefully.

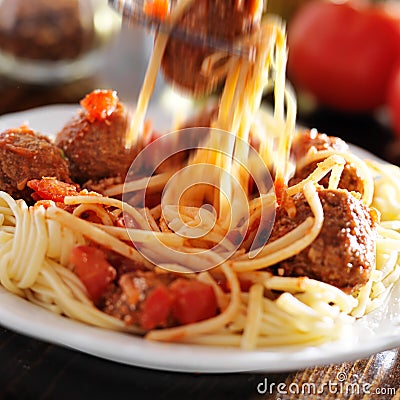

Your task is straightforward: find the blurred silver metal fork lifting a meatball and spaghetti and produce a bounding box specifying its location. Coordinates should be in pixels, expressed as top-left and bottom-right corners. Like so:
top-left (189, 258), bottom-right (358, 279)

top-left (108, 0), bottom-right (254, 60)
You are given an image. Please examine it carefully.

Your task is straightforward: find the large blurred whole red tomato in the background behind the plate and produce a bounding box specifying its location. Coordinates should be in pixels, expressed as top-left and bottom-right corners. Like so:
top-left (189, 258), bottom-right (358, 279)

top-left (288, 1), bottom-right (400, 111)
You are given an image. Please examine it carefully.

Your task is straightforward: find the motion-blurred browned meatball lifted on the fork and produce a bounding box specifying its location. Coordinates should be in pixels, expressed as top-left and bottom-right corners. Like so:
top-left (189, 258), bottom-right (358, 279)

top-left (162, 0), bottom-right (262, 95)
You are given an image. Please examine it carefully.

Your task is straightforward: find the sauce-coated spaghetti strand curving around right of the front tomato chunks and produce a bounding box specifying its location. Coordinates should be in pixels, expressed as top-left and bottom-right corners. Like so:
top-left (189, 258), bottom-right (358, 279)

top-left (146, 263), bottom-right (241, 341)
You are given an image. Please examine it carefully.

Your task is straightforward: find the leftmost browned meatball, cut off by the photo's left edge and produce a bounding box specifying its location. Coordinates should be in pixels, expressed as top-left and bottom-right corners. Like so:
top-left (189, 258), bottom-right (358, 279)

top-left (0, 126), bottom-right (72, 203)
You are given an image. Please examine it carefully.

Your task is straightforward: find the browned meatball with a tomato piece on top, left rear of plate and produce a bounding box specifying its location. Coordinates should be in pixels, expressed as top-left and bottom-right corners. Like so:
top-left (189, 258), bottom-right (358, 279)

top-left (55, 90), bottom-right (137, 184)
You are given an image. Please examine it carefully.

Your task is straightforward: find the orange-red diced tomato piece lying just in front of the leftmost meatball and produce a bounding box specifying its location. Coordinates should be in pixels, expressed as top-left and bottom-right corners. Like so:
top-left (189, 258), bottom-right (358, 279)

top-left (27, 178), bottom-right (79, 203)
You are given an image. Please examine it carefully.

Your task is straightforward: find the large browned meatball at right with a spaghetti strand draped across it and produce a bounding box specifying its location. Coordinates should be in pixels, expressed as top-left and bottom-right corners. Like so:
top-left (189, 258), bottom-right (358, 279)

top-left (270, 189), bottom-right (377, 292)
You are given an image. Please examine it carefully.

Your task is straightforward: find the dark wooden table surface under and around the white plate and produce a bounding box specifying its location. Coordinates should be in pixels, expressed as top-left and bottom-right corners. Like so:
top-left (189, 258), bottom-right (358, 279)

top-left (0, 26), bottom-right (400, 400)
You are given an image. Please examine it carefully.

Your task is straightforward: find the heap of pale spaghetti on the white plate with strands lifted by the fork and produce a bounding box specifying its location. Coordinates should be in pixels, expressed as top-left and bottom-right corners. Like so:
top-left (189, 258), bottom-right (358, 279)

top-left (0, 1), bottom-right (400, 350)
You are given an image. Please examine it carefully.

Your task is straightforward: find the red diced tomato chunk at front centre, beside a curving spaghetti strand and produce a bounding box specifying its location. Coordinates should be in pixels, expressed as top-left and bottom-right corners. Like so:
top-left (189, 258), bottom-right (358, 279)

top-left (169, 278), bottom-right (218, 324)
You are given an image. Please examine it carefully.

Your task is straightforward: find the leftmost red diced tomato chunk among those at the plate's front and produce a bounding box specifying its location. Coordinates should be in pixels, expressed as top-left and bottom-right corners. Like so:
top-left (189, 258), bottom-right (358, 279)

top-left (70, 246), bottom-right (117, 302)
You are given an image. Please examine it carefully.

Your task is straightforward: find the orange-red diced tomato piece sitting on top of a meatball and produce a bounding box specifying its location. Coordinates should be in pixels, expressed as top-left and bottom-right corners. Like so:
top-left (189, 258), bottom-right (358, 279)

top-left (81, 89), bottom-right (119, 122)
